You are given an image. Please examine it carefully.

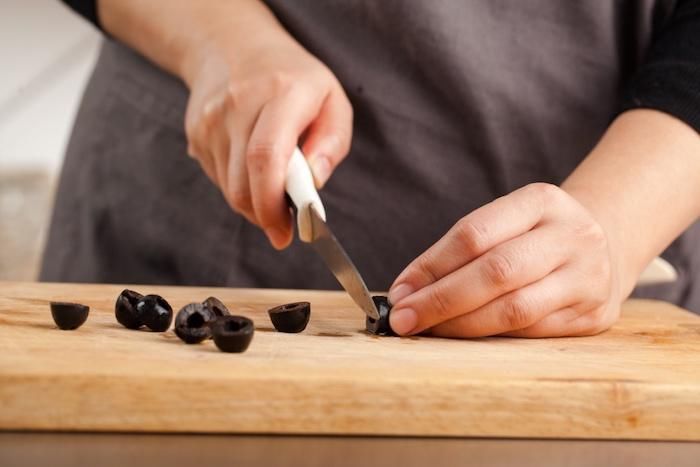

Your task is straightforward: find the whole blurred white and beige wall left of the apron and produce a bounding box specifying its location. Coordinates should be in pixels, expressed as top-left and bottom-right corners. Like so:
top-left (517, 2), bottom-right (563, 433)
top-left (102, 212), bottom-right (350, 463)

top-left (0, 0), bottom-right (100, 280)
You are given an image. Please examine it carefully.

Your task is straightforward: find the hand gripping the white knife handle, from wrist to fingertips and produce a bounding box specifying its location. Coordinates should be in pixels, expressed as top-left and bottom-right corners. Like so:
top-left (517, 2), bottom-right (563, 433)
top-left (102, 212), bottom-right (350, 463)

top-left (180, 5), bottom-right (352, 249)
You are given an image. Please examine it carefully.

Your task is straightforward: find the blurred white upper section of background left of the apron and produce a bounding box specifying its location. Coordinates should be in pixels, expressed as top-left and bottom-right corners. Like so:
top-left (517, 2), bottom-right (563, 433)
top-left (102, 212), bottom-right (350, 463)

top-left (0, 0), bottom-right (100, 176)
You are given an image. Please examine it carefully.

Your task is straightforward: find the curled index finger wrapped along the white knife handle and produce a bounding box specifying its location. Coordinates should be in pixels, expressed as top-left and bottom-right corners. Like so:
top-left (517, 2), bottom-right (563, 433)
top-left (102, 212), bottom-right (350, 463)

top-left (246, 87), bottom-right (323, 249)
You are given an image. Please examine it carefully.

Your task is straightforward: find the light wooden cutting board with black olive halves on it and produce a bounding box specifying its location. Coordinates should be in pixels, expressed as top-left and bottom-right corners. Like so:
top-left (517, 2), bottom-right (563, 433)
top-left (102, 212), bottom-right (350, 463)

top-left (0, 283), bottom-right (700, 440)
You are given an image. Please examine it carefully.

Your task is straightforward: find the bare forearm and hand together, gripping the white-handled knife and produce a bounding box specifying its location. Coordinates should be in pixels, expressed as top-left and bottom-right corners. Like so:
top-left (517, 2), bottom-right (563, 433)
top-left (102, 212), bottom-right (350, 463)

top-left (99, 0), bottom-right (352, 249)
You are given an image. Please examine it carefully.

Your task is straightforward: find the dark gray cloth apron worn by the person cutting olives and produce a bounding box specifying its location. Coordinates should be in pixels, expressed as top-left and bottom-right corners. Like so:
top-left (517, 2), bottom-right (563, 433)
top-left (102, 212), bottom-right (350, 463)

top-left (41, 0), bottom-right (700, 311)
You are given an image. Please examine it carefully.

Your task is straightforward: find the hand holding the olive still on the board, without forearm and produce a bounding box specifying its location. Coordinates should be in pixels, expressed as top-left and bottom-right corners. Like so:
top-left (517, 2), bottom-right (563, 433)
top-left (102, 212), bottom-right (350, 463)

top-left (389, 183), bottom-right (623, 337)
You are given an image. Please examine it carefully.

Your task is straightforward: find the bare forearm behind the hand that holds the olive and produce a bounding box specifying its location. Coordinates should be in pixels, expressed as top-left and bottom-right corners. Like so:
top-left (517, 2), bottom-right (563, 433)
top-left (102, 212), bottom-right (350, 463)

top-left (562, 109), bottom-right (700, 294)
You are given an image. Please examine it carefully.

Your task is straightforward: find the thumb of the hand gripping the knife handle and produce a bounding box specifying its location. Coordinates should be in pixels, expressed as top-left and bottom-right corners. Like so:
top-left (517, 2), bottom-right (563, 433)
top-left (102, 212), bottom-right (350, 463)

top-left (302, 88), bottom-right (352, 189)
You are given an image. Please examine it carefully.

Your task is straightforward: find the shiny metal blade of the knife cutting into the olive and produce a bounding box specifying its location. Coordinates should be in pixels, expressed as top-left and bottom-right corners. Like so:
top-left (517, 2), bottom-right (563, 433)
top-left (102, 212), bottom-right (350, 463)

top-left (308, 204), bottom-right (379, 319)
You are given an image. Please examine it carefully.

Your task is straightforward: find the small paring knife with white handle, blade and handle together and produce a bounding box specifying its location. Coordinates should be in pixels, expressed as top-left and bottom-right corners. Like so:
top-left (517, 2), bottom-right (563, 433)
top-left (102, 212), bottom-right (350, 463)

top-left (285, 148), bottom-right (379, 319)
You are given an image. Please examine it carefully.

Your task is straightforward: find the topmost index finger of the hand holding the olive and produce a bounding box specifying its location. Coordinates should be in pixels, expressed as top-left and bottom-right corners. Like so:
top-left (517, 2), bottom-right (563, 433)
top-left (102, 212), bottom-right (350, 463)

top-left (389, 183), bottom-right (557, 304)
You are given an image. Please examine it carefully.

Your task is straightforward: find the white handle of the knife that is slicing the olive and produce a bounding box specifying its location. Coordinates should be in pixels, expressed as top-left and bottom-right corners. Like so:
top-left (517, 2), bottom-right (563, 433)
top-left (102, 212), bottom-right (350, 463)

top-left (285, 147), bottom-right (326, 242)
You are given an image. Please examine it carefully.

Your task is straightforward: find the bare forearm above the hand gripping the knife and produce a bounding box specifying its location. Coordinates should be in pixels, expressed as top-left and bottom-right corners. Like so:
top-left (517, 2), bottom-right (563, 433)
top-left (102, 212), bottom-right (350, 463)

top-left (98, 0), bottom-right (286, 84)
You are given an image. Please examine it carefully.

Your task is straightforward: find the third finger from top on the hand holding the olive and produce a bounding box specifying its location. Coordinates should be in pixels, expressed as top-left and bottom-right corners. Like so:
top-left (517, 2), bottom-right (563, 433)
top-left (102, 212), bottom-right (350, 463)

top-left (430, 269), bottom-right (583, 337)
